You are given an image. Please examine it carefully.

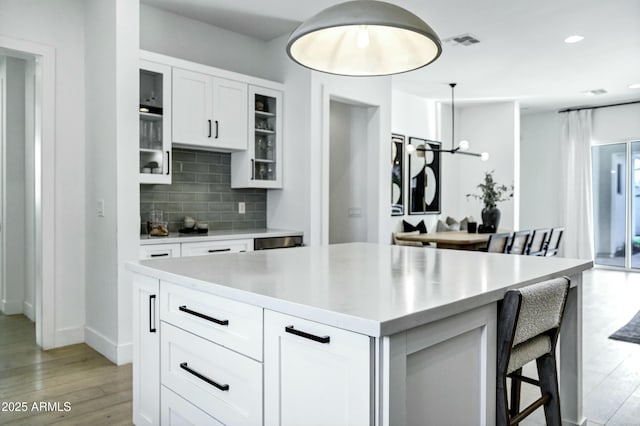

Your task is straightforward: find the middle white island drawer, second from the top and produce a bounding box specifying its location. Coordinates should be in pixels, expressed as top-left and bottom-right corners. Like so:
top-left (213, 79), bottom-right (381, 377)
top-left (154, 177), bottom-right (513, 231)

top-left (160, 322), bottom-right (262, 425)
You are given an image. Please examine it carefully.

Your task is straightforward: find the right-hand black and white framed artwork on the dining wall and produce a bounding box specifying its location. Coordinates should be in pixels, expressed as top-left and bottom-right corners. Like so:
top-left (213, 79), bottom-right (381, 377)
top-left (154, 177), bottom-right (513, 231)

top-left (409, 137), bottom-right (442, 214)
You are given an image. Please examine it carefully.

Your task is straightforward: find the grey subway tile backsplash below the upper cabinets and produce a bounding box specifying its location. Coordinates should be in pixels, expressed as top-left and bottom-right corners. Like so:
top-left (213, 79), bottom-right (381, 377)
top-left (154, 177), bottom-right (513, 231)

top-left (140, 148), bottom-right (267, 232)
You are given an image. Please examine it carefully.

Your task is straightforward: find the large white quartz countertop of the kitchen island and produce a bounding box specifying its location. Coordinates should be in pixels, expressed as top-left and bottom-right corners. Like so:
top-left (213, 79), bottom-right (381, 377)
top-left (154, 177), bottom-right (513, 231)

top-left (127, 243), bottom-right (593, 336)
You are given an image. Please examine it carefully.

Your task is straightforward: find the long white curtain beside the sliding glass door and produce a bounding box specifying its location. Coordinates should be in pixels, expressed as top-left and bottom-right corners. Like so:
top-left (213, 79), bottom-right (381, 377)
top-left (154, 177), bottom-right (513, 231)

top-left (560, 109), bottom-right (593, 260)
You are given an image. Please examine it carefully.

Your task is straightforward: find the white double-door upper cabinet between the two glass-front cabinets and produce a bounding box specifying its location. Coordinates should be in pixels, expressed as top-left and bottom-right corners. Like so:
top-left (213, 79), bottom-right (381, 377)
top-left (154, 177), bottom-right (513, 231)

top-left (173, 68), bottom-right (248, 151)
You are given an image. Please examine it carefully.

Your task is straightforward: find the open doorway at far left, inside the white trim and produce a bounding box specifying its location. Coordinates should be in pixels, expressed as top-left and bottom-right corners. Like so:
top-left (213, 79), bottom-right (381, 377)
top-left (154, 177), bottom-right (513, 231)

top-left (0, 55), bottom-right (36, 321)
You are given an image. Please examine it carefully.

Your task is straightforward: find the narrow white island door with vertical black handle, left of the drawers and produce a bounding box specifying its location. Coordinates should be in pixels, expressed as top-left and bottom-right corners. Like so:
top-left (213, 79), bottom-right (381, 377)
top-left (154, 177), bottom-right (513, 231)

top-left (133, 275), bottom-right (160, 426)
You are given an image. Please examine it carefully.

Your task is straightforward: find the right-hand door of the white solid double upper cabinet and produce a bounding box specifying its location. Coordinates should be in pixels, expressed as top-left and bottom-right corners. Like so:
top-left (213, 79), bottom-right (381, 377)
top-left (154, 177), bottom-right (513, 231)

top-left (213, 77), bottom-right (248, 151)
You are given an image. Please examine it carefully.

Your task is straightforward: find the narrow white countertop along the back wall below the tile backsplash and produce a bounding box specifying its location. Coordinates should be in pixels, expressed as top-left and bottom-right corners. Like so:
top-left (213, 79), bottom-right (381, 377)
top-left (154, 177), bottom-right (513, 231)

top-left (140, 228), bottom-right (302, 245)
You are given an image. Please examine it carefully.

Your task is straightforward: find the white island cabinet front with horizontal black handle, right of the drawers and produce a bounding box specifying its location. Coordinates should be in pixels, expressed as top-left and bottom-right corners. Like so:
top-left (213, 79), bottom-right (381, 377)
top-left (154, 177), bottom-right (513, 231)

top-left (264, 310), bottom-right (373, 426)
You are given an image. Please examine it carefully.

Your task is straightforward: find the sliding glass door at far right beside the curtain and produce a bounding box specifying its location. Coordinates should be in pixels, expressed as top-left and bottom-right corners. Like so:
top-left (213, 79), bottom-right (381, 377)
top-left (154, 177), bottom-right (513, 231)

top-left (592, 142), bottom-right (640, 269)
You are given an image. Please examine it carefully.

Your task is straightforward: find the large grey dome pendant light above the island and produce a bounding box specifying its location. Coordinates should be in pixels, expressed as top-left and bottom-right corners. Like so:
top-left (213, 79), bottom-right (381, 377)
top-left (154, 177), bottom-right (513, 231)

top-left (287, 0), bottom-right (442, 76)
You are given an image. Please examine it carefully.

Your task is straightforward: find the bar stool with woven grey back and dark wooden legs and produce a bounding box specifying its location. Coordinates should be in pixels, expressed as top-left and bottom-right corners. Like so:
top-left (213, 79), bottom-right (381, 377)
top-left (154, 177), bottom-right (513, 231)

top-left (496, 278), bottom-right (569, 426)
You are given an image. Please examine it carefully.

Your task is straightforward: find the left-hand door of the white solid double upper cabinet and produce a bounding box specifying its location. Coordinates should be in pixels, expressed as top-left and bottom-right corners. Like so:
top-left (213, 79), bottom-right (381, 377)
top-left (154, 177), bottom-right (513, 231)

top-left (173, 68), bottom-right (215, 146)
